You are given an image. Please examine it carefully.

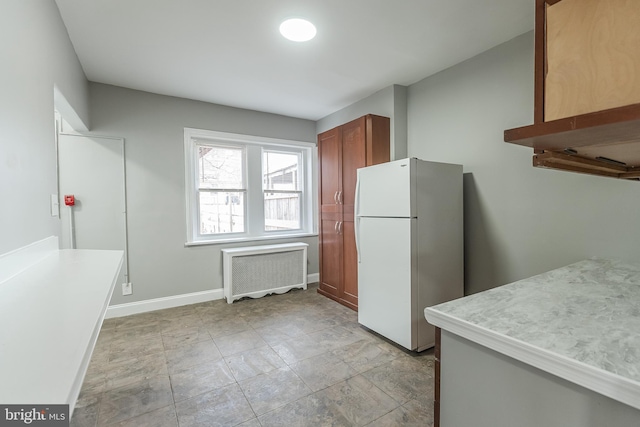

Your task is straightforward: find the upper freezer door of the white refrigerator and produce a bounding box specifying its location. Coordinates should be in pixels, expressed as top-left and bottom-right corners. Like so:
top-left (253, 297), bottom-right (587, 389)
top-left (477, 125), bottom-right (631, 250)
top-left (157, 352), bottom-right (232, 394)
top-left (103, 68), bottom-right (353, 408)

top-left (355, 159), bottom-right (416, 218)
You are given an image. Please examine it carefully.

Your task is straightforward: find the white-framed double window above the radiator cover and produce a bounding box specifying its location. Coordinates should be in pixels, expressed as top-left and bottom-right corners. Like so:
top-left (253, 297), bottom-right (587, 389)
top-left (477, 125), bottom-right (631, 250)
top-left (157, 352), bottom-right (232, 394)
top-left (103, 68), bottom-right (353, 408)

top-left (185, 128), bottom-right (316, 244)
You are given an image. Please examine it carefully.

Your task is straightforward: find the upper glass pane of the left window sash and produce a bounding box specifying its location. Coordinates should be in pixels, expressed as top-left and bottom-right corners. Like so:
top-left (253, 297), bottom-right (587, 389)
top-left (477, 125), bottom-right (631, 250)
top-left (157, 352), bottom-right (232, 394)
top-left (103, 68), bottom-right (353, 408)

top-left (198, 145), bottom-right (245, 189)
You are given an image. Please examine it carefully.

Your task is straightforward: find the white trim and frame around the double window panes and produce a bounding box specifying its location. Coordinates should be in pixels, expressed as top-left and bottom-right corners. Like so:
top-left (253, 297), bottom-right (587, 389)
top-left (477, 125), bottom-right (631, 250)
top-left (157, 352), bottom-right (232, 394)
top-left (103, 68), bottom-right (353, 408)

top-left (184, 128), bottom-right (318, 246)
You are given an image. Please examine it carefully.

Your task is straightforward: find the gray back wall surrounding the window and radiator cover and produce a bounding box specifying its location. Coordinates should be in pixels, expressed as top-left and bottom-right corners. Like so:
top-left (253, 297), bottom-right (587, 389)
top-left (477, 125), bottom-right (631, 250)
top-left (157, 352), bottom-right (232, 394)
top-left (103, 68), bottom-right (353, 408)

top-left (90, 83), bottom-right (318, 305)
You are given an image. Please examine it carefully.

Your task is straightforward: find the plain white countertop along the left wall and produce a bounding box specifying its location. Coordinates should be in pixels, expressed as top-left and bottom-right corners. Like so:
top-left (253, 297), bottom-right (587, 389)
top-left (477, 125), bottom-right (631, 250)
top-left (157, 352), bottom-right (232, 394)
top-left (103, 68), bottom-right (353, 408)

top-left (0, 250), bottom-right (123, 411)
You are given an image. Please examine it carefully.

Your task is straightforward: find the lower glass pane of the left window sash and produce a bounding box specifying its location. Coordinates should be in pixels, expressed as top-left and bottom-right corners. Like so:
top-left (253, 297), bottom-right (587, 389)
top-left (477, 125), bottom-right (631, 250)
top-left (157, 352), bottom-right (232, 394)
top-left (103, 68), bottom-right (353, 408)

top-left (199, 191), bottom-right (245, 234)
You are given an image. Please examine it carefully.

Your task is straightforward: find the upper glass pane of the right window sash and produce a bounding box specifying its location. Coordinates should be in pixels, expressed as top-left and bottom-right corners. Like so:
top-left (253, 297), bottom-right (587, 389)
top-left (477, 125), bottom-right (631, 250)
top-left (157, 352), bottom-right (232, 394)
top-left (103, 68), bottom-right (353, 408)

top-left (262, 151), bottom-right (300, 191)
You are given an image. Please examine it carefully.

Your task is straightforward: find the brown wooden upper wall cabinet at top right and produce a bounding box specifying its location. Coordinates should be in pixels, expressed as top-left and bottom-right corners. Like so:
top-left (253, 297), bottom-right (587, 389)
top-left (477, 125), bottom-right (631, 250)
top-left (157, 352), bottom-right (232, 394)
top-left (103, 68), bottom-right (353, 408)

top-left (504, 0), bottom-right (640, 180)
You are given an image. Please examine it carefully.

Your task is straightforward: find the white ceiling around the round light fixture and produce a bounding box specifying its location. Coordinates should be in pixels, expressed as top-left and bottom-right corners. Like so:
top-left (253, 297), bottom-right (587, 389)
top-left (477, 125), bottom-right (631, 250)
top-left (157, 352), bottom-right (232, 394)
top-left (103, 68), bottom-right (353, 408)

top-left (56, 0), bottom-right (535, 120)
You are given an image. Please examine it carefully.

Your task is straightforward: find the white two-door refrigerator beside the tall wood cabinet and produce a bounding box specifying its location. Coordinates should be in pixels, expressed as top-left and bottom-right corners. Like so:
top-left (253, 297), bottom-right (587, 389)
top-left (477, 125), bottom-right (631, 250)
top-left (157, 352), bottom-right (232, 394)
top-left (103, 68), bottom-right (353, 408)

top-left (354, 158), bottom-right (464, 351)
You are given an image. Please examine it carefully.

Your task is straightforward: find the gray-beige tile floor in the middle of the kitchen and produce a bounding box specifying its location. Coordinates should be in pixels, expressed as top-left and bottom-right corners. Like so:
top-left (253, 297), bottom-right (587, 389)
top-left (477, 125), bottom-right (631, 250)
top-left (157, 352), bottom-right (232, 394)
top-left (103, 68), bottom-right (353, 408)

top-left (71, 285), bottom-right (433, 427)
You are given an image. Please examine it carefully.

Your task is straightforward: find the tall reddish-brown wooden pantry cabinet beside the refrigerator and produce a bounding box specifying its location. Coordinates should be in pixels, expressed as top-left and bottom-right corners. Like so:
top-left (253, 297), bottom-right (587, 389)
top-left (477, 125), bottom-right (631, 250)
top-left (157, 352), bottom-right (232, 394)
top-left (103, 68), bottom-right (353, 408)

top-left (318, 114), bottom-right (390, 310)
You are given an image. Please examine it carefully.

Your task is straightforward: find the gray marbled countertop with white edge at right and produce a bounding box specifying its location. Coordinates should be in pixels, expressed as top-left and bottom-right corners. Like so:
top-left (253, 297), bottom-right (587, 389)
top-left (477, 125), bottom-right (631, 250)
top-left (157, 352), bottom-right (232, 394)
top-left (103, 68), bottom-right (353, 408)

top-left (425, 259), bottom-right (640, 409)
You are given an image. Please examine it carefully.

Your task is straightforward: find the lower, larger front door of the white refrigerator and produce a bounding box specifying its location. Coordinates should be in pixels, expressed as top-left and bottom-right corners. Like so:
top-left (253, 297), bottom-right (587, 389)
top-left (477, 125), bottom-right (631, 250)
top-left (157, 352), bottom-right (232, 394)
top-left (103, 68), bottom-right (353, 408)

top-left (356, 218), bottom-right (417, 350)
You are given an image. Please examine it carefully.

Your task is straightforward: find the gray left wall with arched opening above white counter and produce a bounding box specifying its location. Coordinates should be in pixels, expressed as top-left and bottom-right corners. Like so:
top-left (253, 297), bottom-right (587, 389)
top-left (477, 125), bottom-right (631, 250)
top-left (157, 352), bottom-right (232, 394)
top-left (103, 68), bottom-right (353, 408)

top-left (0, 0), bottom-right (89, 254)
